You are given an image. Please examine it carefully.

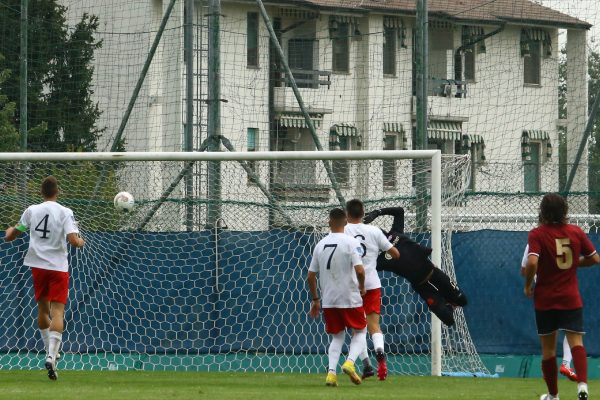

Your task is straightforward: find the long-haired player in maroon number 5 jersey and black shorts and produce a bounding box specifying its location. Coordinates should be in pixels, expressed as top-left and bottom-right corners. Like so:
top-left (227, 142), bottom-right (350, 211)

top-left (524, 194), bottom-right (600, 400)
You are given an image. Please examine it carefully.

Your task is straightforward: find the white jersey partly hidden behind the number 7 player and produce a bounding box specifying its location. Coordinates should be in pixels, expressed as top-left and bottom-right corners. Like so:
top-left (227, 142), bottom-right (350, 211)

top-left (344, 224), bottom-right (393, 290)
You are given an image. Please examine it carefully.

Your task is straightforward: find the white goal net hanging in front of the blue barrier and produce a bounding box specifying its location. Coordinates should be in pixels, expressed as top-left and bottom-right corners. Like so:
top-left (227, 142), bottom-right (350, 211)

top-left (0, 151), bottom-right (487, 375)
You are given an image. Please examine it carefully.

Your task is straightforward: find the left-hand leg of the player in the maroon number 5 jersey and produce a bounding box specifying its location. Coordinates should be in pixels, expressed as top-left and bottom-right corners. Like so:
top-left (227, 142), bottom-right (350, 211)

top-left (535, 310), bottom-right (558, 400)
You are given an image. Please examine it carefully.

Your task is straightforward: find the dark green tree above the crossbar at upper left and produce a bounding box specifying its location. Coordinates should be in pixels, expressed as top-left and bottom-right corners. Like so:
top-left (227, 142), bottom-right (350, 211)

top-left (0, 0), bottom-right (104, 151)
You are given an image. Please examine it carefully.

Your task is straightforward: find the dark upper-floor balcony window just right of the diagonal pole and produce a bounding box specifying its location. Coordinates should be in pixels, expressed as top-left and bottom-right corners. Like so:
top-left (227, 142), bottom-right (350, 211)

top-left (288, 39), bottom-right (319, 89)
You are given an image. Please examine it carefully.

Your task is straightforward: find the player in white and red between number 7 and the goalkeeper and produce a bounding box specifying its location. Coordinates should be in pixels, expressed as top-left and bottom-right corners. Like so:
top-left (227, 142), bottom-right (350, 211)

top-left (344, 199), bottom-right (400, 380)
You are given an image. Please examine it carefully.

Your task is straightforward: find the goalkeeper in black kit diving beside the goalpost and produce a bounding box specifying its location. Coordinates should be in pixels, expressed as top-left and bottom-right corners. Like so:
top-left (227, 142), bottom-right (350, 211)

top-left (363, 207), bottom-right (467, 326)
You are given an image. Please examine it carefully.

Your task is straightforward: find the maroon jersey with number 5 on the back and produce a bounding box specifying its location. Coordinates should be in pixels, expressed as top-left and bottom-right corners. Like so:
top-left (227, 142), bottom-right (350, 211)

top-left (528, 224), bottom-right (596, 310)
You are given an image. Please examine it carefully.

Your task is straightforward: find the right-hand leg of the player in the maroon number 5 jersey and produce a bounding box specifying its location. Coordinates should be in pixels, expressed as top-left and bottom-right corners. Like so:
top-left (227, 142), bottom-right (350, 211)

top-left (561, 308), bottom-right (588, 400)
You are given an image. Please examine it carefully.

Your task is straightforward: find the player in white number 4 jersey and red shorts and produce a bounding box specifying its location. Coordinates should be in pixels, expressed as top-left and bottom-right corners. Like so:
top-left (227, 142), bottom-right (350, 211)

top-left (4, 176), bottom-right (85, 380)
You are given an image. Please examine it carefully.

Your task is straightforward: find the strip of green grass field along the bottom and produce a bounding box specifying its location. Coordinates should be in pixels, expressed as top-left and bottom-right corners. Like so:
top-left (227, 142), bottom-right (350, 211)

top-left (0, 371), bottom-right (600, 400)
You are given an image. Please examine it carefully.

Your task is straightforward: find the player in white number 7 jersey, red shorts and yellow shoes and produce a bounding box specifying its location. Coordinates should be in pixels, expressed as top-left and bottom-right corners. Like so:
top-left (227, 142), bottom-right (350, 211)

top-left (307, 208), bottom-right (367, 386)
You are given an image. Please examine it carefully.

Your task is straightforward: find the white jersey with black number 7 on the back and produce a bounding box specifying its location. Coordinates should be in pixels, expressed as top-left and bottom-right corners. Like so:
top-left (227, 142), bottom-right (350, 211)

top-left (308, 233), bottom-right (362, 308)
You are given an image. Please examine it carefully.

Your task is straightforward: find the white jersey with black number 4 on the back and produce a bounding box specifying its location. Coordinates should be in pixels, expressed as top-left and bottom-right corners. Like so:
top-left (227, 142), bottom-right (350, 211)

top-left (19, 201), bottom-right (79, 272)
